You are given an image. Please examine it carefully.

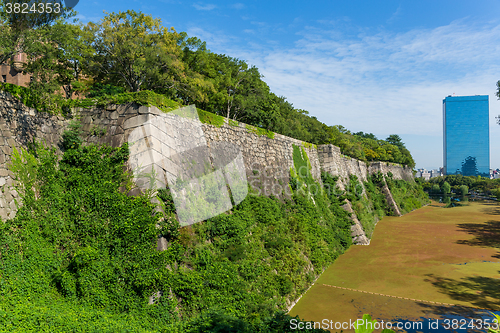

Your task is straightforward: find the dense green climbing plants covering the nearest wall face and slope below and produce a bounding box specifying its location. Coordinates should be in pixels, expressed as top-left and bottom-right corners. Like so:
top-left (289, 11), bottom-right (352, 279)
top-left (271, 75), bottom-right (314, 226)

top-left (0, 137), bottom-right (351, 332)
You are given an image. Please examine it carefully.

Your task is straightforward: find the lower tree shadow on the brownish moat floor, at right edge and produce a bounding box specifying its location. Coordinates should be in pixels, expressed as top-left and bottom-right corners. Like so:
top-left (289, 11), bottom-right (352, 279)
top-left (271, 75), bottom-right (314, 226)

top-left (425, 274), bottom-right (500, 314)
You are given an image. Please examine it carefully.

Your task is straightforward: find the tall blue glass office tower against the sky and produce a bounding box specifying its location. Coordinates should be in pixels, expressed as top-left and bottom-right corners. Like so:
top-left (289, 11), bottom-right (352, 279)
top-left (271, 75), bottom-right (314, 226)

top-left (443, 95), bottom-right (490, 178)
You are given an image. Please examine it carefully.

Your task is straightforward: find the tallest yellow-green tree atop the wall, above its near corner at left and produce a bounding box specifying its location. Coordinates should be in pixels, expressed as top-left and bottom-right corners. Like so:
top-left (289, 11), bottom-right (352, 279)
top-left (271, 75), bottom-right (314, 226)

top-left (85, 10), bottom-right (188, 98)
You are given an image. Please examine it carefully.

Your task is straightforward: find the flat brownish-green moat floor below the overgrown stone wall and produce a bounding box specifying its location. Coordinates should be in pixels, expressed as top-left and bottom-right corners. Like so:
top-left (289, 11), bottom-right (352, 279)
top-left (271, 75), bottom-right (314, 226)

top-left (290, 202), bottom-right (500, 332)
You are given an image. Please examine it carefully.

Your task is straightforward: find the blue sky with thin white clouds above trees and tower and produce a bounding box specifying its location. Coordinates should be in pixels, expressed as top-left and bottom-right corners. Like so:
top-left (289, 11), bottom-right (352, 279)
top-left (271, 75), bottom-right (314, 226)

top-left (71, 0), bottom-right (500, 169)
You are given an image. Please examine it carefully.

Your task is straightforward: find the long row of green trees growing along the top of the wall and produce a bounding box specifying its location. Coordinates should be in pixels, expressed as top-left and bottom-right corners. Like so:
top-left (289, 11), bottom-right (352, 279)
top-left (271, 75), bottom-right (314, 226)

top-left (0, 10), bottom-right (415, 167)
